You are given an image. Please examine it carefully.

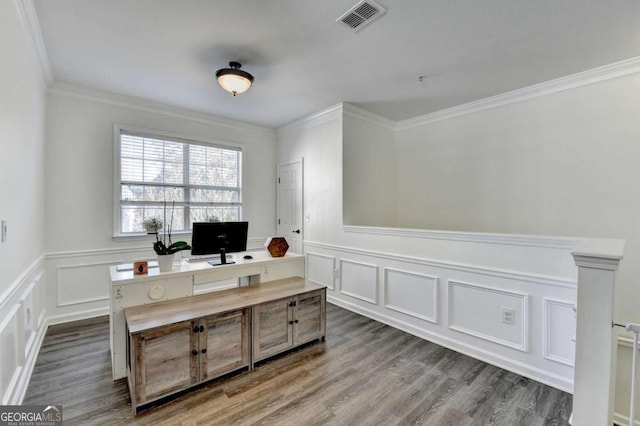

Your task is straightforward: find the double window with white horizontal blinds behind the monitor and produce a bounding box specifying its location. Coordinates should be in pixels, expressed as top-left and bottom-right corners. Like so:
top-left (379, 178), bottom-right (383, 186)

top-left (116, 128), bottom-right (242, 235)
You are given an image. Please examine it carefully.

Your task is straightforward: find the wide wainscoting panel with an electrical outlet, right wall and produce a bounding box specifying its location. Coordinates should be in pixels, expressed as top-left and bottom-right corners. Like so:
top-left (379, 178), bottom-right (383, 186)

top-left (447, 281), bottom-right (529, 352)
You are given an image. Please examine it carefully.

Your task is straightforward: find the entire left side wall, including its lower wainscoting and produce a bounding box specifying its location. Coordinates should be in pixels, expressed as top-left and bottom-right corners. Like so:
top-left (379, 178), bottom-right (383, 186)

top-left (0, 1), bottom-right (46, 404)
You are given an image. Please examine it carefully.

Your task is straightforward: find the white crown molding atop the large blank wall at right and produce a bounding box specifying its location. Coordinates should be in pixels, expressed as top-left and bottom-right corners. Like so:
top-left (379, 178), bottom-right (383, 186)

top-left (396, 57), bottom-right (640, 130)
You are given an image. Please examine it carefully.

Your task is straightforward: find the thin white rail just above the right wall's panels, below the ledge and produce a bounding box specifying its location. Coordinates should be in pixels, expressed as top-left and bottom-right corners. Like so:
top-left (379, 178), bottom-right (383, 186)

top-left (303, 241), bottom-right (576, 289)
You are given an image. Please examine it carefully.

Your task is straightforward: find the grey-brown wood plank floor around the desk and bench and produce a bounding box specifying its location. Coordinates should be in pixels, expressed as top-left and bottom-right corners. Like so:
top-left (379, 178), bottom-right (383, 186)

top-left (24, 305), bottom-right (572, 426)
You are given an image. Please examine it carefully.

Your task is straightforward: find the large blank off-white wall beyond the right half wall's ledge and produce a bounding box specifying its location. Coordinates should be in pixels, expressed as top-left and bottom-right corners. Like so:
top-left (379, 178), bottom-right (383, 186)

top-left (397, 74), bottom-right (640, 322)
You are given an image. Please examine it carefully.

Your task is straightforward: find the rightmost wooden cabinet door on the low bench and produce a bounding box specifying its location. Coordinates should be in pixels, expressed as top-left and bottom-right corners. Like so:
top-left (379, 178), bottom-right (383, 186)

top-left (293, 290), bottom-right (326, 345)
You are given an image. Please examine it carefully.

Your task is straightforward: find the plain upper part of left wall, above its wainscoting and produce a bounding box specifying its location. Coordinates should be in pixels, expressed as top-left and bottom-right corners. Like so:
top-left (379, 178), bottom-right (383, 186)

top-left (0, 2), bottom-right (45, 294)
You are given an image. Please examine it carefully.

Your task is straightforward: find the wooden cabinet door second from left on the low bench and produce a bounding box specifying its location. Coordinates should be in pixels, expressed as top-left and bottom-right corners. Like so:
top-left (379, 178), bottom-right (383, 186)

top-left (200, 309), bottom-right (249, 380)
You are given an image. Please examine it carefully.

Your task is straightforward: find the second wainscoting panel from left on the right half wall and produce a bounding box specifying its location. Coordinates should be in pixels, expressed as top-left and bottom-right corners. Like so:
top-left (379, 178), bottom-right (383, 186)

top-left (340, 259), bottom-right (378, 305)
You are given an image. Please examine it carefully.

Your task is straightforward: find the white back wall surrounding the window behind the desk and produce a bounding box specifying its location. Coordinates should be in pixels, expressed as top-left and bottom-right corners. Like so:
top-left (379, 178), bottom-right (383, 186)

top-left (46, 83), bottom-right (276, 322)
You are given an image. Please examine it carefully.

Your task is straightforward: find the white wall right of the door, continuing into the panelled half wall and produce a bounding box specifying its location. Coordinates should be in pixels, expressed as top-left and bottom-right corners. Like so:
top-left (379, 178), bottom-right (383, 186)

top-left (278, 106), bottom-right (579, 391)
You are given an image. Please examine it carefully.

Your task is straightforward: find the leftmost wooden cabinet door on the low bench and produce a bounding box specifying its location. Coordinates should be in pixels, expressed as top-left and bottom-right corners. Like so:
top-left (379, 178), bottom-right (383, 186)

top-left (135, 321), bottom-right (198, 404)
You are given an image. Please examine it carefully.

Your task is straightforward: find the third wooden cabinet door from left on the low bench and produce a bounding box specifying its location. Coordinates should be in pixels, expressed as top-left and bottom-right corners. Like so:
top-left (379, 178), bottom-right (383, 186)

top-left (253, 298), bottom-right (293, 361)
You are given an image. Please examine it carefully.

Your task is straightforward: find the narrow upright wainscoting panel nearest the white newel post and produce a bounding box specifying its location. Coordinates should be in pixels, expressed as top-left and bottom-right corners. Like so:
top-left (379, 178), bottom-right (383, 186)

top-left (543, 297), bottom-right (576, 367)
